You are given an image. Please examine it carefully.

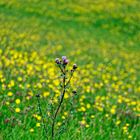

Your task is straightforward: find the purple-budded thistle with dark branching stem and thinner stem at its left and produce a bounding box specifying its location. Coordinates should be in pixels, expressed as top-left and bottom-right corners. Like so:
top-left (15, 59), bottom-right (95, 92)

top-left (36, 56), bottom-right (77, 139)
